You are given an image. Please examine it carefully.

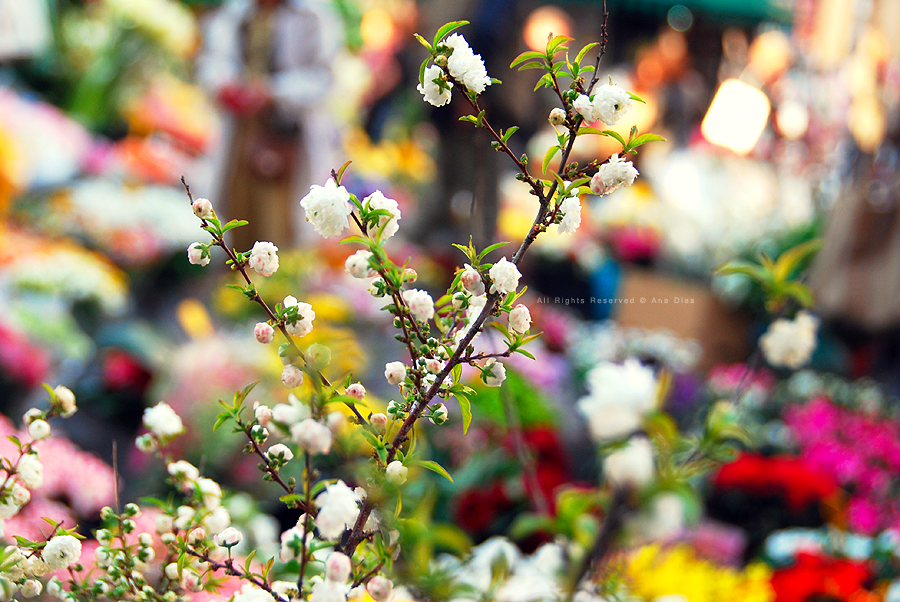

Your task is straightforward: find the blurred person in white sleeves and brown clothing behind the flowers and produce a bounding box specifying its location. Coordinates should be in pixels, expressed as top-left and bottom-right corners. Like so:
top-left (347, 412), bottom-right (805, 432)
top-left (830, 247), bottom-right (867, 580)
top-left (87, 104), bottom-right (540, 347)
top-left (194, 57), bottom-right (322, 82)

top-left (197, 0), bottom-right (343, 250)
